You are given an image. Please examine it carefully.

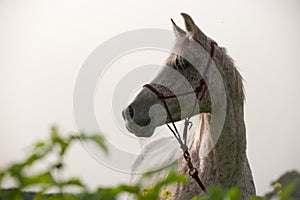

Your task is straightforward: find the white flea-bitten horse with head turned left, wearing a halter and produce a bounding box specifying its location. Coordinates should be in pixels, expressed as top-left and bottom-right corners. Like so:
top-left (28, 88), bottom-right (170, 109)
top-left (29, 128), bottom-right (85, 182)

top-left (123, 13), bottom-right (255, 199)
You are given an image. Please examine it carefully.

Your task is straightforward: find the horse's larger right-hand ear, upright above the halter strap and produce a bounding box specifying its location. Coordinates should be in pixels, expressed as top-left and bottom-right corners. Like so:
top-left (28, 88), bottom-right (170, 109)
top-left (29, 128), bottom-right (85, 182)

top-left (181, 13), bottom-right (206, 43)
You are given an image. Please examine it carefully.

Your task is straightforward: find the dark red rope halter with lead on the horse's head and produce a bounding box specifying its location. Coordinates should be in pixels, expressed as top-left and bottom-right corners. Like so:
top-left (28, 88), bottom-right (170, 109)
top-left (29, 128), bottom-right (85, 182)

top-left (143, 41), bottom-right (217, 192)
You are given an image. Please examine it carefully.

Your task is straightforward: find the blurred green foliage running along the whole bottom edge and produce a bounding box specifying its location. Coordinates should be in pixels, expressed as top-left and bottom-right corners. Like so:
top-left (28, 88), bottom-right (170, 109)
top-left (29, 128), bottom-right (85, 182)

top-left (0, 127), bottom-right (296, 200)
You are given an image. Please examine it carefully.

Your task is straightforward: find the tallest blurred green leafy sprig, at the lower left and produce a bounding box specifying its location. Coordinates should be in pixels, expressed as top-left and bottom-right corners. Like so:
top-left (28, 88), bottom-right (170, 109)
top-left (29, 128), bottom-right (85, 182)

top-left (0, 127), bottom-right (108, 199)
